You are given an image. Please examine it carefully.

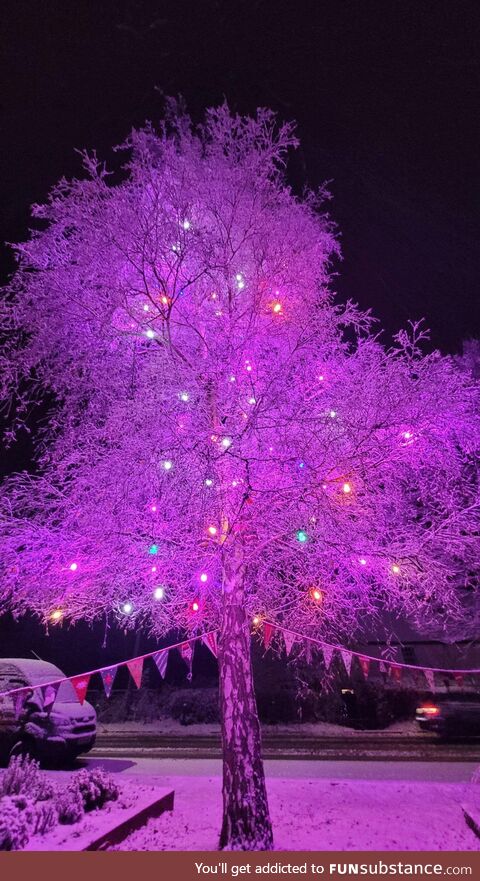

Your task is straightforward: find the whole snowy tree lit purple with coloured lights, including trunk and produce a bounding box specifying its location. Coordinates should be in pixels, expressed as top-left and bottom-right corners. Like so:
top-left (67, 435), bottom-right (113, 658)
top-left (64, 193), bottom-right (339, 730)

top-left (1, 107), bottom-right (478, 849)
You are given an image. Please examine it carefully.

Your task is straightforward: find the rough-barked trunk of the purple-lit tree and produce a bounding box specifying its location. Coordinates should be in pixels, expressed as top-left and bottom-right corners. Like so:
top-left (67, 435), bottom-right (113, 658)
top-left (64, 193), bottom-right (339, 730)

top-left (218, 546), bottom-right (273, 850)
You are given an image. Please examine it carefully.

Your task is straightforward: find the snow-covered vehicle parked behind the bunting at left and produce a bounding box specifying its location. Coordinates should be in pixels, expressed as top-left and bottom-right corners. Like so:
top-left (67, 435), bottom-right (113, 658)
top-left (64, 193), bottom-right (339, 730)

top-left (0, 658), bottom-right (97, 764)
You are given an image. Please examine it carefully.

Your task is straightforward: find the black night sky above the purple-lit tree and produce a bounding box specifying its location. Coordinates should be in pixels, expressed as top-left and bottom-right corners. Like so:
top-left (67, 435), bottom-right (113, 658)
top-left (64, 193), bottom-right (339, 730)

top-left (0, 0), bottom-right (480, 351)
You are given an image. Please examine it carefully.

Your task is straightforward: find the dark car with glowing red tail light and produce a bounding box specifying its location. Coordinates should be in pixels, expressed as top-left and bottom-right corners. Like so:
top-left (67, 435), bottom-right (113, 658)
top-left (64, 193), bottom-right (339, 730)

top-left (415, 692), bottom-right (480, 737)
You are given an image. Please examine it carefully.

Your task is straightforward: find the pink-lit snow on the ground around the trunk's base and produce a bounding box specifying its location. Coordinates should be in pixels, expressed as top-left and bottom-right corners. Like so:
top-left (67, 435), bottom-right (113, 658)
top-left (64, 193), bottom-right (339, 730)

top-left (109, 776), bottom-right (480, 851)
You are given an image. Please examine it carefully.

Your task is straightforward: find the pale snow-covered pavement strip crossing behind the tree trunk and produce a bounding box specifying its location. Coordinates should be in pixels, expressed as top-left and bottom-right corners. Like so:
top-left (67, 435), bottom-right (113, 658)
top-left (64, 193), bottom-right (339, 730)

top-left (79, 757), bottom-right (478, 783)
